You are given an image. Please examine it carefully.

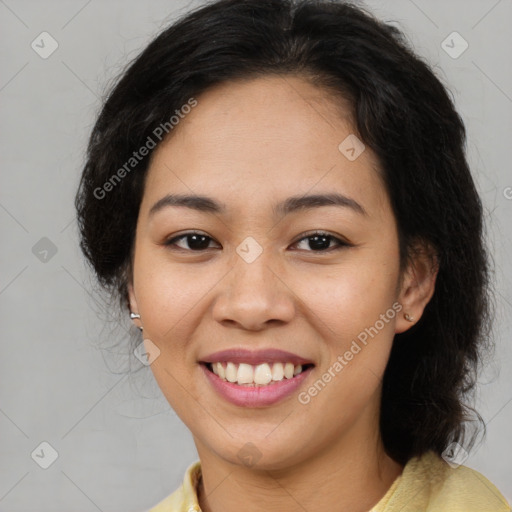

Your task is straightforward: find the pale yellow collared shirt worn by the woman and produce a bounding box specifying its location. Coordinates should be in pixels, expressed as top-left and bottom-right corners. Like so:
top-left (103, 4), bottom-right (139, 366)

top-left (148, 452), bottom-right (511, 512)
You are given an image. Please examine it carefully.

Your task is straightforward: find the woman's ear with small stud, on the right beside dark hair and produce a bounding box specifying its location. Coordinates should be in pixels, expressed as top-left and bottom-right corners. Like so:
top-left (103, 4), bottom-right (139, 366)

top-left (395, 241), bottom-right (439, 334)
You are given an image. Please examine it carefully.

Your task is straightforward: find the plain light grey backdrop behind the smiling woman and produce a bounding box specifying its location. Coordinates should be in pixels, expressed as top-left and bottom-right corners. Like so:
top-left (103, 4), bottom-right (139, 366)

top-left (0, 0), bottom-right (512, 512)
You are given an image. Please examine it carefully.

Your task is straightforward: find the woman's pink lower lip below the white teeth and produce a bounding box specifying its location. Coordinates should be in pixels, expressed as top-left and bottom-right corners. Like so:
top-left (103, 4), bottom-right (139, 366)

top-left (200, 364), bottom-right (313, 407)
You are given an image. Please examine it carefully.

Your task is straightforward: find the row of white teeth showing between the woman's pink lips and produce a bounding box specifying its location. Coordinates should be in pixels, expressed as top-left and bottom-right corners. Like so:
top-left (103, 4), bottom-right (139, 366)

top-left (203, 361), bottom-right (314, 387)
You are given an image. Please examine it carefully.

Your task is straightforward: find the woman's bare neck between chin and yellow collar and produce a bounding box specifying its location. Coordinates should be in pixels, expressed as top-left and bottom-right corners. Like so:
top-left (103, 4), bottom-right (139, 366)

top-left (195, 402), bottom-right (403, 512)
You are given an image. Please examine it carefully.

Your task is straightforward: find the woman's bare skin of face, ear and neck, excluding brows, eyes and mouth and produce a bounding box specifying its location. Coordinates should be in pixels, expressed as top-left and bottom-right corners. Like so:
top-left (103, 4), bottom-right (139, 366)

top-left (129, 76), bottom-right (436, 512)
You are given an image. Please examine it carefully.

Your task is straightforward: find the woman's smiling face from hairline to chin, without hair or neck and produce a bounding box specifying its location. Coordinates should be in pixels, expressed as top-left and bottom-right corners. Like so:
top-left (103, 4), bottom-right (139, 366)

top-left (129, 76), bottom-right (432, 468)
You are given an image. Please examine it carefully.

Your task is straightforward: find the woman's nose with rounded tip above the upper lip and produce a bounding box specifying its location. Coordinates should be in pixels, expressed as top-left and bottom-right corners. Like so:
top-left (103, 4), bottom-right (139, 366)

top-left (213, 252), bottom-right (295, 331)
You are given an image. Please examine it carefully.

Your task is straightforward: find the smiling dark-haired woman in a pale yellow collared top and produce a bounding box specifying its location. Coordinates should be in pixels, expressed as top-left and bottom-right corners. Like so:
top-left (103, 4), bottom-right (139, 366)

top-left (76, 0), bottom-right (510, 512)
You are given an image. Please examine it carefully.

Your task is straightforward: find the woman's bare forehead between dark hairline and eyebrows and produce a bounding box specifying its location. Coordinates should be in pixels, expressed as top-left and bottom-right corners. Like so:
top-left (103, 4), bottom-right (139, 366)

top-left (141, 76), bottom-right (388, 219)
